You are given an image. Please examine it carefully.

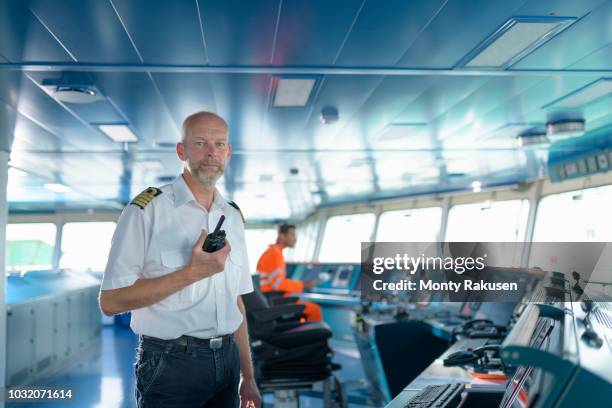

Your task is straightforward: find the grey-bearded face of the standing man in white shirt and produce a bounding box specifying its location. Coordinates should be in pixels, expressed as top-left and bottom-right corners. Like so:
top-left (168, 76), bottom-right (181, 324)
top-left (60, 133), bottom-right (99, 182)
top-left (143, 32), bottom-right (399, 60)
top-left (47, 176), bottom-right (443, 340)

top-left (177, 117), bottom-right (231, 186)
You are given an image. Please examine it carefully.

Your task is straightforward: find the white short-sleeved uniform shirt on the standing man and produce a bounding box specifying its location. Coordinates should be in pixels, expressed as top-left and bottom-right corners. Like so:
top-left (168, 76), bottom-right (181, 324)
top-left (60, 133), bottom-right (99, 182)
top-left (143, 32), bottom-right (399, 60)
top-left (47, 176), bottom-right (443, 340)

top-left (102, 176), bottom-right (253, 339)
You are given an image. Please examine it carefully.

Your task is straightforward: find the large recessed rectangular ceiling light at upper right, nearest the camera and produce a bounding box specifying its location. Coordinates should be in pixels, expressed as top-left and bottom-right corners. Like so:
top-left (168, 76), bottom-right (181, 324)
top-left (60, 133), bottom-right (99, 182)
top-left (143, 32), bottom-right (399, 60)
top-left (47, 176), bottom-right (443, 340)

top-left (457, 17), bottom-right (576, 69)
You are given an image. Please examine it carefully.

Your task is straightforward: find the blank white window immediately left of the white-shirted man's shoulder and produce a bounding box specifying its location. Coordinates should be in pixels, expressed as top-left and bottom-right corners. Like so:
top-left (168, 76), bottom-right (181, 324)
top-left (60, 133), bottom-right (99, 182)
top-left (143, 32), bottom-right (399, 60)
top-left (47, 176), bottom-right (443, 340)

top-left (59, 221), bottom-right (116, 272)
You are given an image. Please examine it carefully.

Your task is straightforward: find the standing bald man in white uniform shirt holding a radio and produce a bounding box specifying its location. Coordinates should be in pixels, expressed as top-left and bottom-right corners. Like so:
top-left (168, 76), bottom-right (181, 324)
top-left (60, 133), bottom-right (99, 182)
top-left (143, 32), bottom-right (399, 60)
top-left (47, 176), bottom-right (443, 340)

top-left (100, 112), bottom-right (261, 408)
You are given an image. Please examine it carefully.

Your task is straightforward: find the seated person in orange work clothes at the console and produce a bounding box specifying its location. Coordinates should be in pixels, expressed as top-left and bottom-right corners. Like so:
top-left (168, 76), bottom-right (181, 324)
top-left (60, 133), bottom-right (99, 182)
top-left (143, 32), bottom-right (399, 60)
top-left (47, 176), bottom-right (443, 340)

top-left (257, 223), bottom-right (323, 322)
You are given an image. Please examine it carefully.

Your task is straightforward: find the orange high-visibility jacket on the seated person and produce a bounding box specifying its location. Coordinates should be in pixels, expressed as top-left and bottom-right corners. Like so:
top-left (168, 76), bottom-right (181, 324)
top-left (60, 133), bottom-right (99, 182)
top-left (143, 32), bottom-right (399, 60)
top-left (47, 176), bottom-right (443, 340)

top-left (257, 244), bottom-right (304, 293)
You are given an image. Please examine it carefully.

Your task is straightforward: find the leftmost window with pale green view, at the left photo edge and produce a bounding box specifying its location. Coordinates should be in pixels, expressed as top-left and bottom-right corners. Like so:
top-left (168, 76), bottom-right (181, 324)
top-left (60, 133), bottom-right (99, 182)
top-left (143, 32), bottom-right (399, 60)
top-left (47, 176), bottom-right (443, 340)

top-left (6, 223), bottom-right (57, 273)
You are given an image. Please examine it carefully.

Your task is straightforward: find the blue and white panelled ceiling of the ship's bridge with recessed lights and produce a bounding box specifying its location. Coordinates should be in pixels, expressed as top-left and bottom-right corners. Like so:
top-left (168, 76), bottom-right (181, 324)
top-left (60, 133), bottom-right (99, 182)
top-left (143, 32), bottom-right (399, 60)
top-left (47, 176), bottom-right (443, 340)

top-left (0, 0), bottom-right (612, 221)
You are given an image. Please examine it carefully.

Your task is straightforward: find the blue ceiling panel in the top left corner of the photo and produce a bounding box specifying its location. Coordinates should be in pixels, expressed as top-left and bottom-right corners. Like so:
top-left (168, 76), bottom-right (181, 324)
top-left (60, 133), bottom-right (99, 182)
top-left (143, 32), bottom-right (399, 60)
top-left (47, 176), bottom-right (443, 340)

top-left (0, 1), bottom-right (70, 62)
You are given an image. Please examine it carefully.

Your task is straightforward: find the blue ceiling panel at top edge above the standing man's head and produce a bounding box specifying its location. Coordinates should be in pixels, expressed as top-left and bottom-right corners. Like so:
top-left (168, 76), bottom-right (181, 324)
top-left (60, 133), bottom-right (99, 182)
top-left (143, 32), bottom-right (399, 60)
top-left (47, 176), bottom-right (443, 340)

top-left (198, 0), bottom-right (280, 65)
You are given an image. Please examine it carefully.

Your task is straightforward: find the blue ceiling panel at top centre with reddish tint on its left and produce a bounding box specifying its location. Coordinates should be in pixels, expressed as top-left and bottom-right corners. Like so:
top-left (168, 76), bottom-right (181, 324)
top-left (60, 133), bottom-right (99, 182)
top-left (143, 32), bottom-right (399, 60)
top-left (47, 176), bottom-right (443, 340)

top-left (274, 0), bottom-right (363, 66)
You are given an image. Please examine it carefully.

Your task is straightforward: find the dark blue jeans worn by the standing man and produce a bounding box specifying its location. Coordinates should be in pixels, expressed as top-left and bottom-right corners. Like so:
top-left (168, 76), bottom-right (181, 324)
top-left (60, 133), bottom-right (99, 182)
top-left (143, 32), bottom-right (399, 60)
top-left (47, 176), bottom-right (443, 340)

top-left (136, 337), bottom-right (240, 408)
